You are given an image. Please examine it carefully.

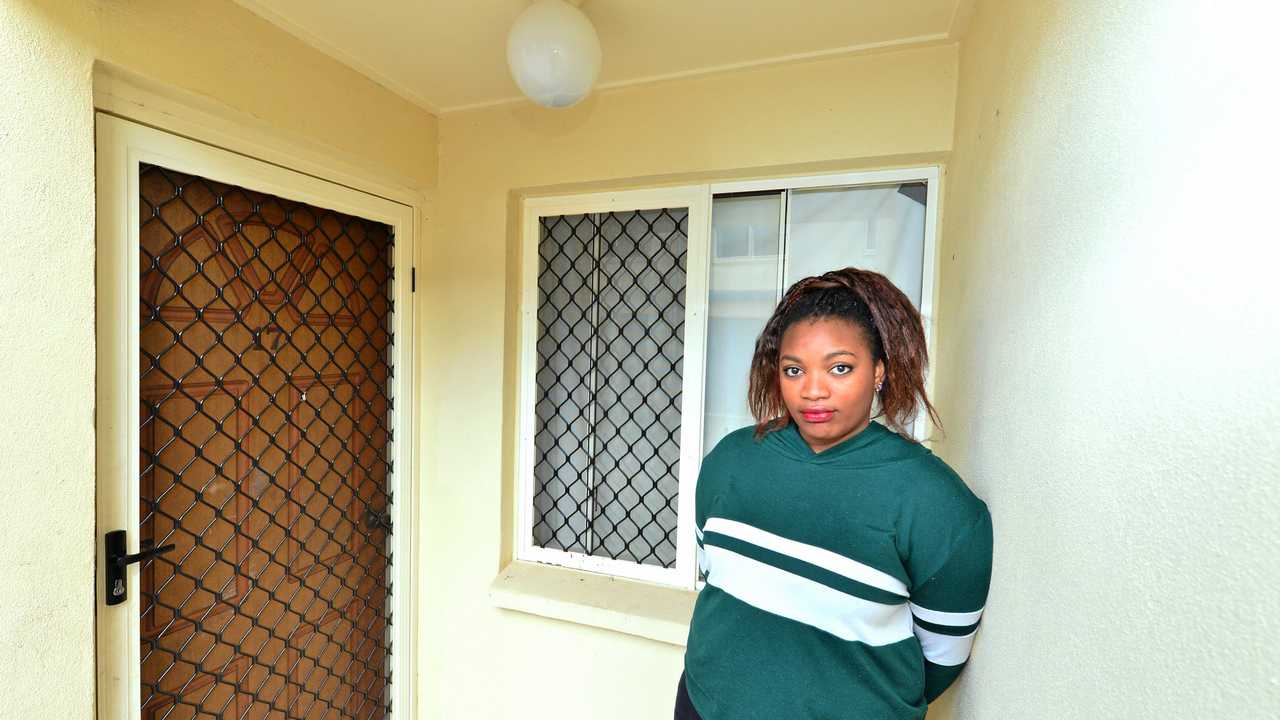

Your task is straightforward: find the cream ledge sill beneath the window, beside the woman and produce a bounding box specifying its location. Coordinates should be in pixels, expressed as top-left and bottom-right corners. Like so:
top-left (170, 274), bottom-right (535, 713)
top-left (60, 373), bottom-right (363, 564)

top-left (489, 561), bottom-right (698, 647)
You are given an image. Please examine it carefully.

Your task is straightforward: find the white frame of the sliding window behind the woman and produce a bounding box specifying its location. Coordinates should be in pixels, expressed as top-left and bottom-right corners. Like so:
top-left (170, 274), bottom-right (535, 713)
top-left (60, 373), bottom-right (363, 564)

top-left (513, 165), bottom-right (942, 591)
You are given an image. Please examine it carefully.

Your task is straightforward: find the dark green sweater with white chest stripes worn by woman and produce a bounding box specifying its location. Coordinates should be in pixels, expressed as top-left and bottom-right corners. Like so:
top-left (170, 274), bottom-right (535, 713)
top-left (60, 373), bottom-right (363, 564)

top-left (685, 423), bottom-right (991, 720)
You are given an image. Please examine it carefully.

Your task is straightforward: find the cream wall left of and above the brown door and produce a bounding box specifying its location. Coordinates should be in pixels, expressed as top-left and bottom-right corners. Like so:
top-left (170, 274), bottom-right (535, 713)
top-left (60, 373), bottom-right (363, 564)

top-left (0, 0), bottom-right (436, 720)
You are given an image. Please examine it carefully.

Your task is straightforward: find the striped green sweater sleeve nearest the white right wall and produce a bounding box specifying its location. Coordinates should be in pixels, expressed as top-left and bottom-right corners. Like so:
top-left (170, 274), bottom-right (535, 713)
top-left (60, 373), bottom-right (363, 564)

top-left (910, 501), bottom-right (992, 702)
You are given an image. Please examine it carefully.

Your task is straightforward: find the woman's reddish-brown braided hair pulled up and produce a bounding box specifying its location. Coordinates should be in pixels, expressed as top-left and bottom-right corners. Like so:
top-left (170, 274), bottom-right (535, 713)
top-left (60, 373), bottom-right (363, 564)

top-left (746, 268), bottom-right (942, 441)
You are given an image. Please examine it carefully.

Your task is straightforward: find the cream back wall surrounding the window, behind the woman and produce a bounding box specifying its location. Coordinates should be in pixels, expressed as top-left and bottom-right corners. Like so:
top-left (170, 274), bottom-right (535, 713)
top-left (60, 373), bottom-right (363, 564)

top-left (420, 46), bottom-right (956, 720)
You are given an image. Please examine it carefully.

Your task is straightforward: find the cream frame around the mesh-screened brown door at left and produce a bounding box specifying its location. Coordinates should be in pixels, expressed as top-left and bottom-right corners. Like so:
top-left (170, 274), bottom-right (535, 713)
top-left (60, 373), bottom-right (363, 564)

top-left (93, 111), bottom-right (421, 720)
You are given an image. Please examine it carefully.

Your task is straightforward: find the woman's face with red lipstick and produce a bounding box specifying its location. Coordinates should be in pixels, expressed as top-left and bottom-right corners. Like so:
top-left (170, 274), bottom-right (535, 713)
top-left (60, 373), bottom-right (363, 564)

top-left (778, 318), bottom-right (884, 452)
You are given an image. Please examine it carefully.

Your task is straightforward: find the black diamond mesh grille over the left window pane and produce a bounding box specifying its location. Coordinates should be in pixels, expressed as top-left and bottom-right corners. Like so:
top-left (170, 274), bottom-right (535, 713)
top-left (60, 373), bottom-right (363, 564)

top-left (534, 208), bottom-right (689, 568)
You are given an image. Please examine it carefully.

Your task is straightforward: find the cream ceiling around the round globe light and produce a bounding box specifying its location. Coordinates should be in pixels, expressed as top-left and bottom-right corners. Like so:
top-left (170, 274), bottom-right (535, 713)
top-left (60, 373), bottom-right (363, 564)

top-left (236, 0), bottom-right (969, 113)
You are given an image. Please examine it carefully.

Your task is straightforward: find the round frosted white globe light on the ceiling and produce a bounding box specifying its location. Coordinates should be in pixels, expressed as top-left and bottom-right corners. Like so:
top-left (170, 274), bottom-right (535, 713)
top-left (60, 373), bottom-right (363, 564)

top-left (507, 0), bottom-right (600, 108)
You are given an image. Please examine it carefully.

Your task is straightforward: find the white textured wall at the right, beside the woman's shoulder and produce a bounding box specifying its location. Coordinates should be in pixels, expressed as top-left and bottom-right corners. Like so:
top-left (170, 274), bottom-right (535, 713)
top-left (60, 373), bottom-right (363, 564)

top-left (931, 0), bottom-right (1280, 720)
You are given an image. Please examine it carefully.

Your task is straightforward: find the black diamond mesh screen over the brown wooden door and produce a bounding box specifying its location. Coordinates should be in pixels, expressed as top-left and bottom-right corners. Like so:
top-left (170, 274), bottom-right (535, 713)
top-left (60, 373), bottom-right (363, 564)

top-left (140, 165), bottom-right (393, 720)
